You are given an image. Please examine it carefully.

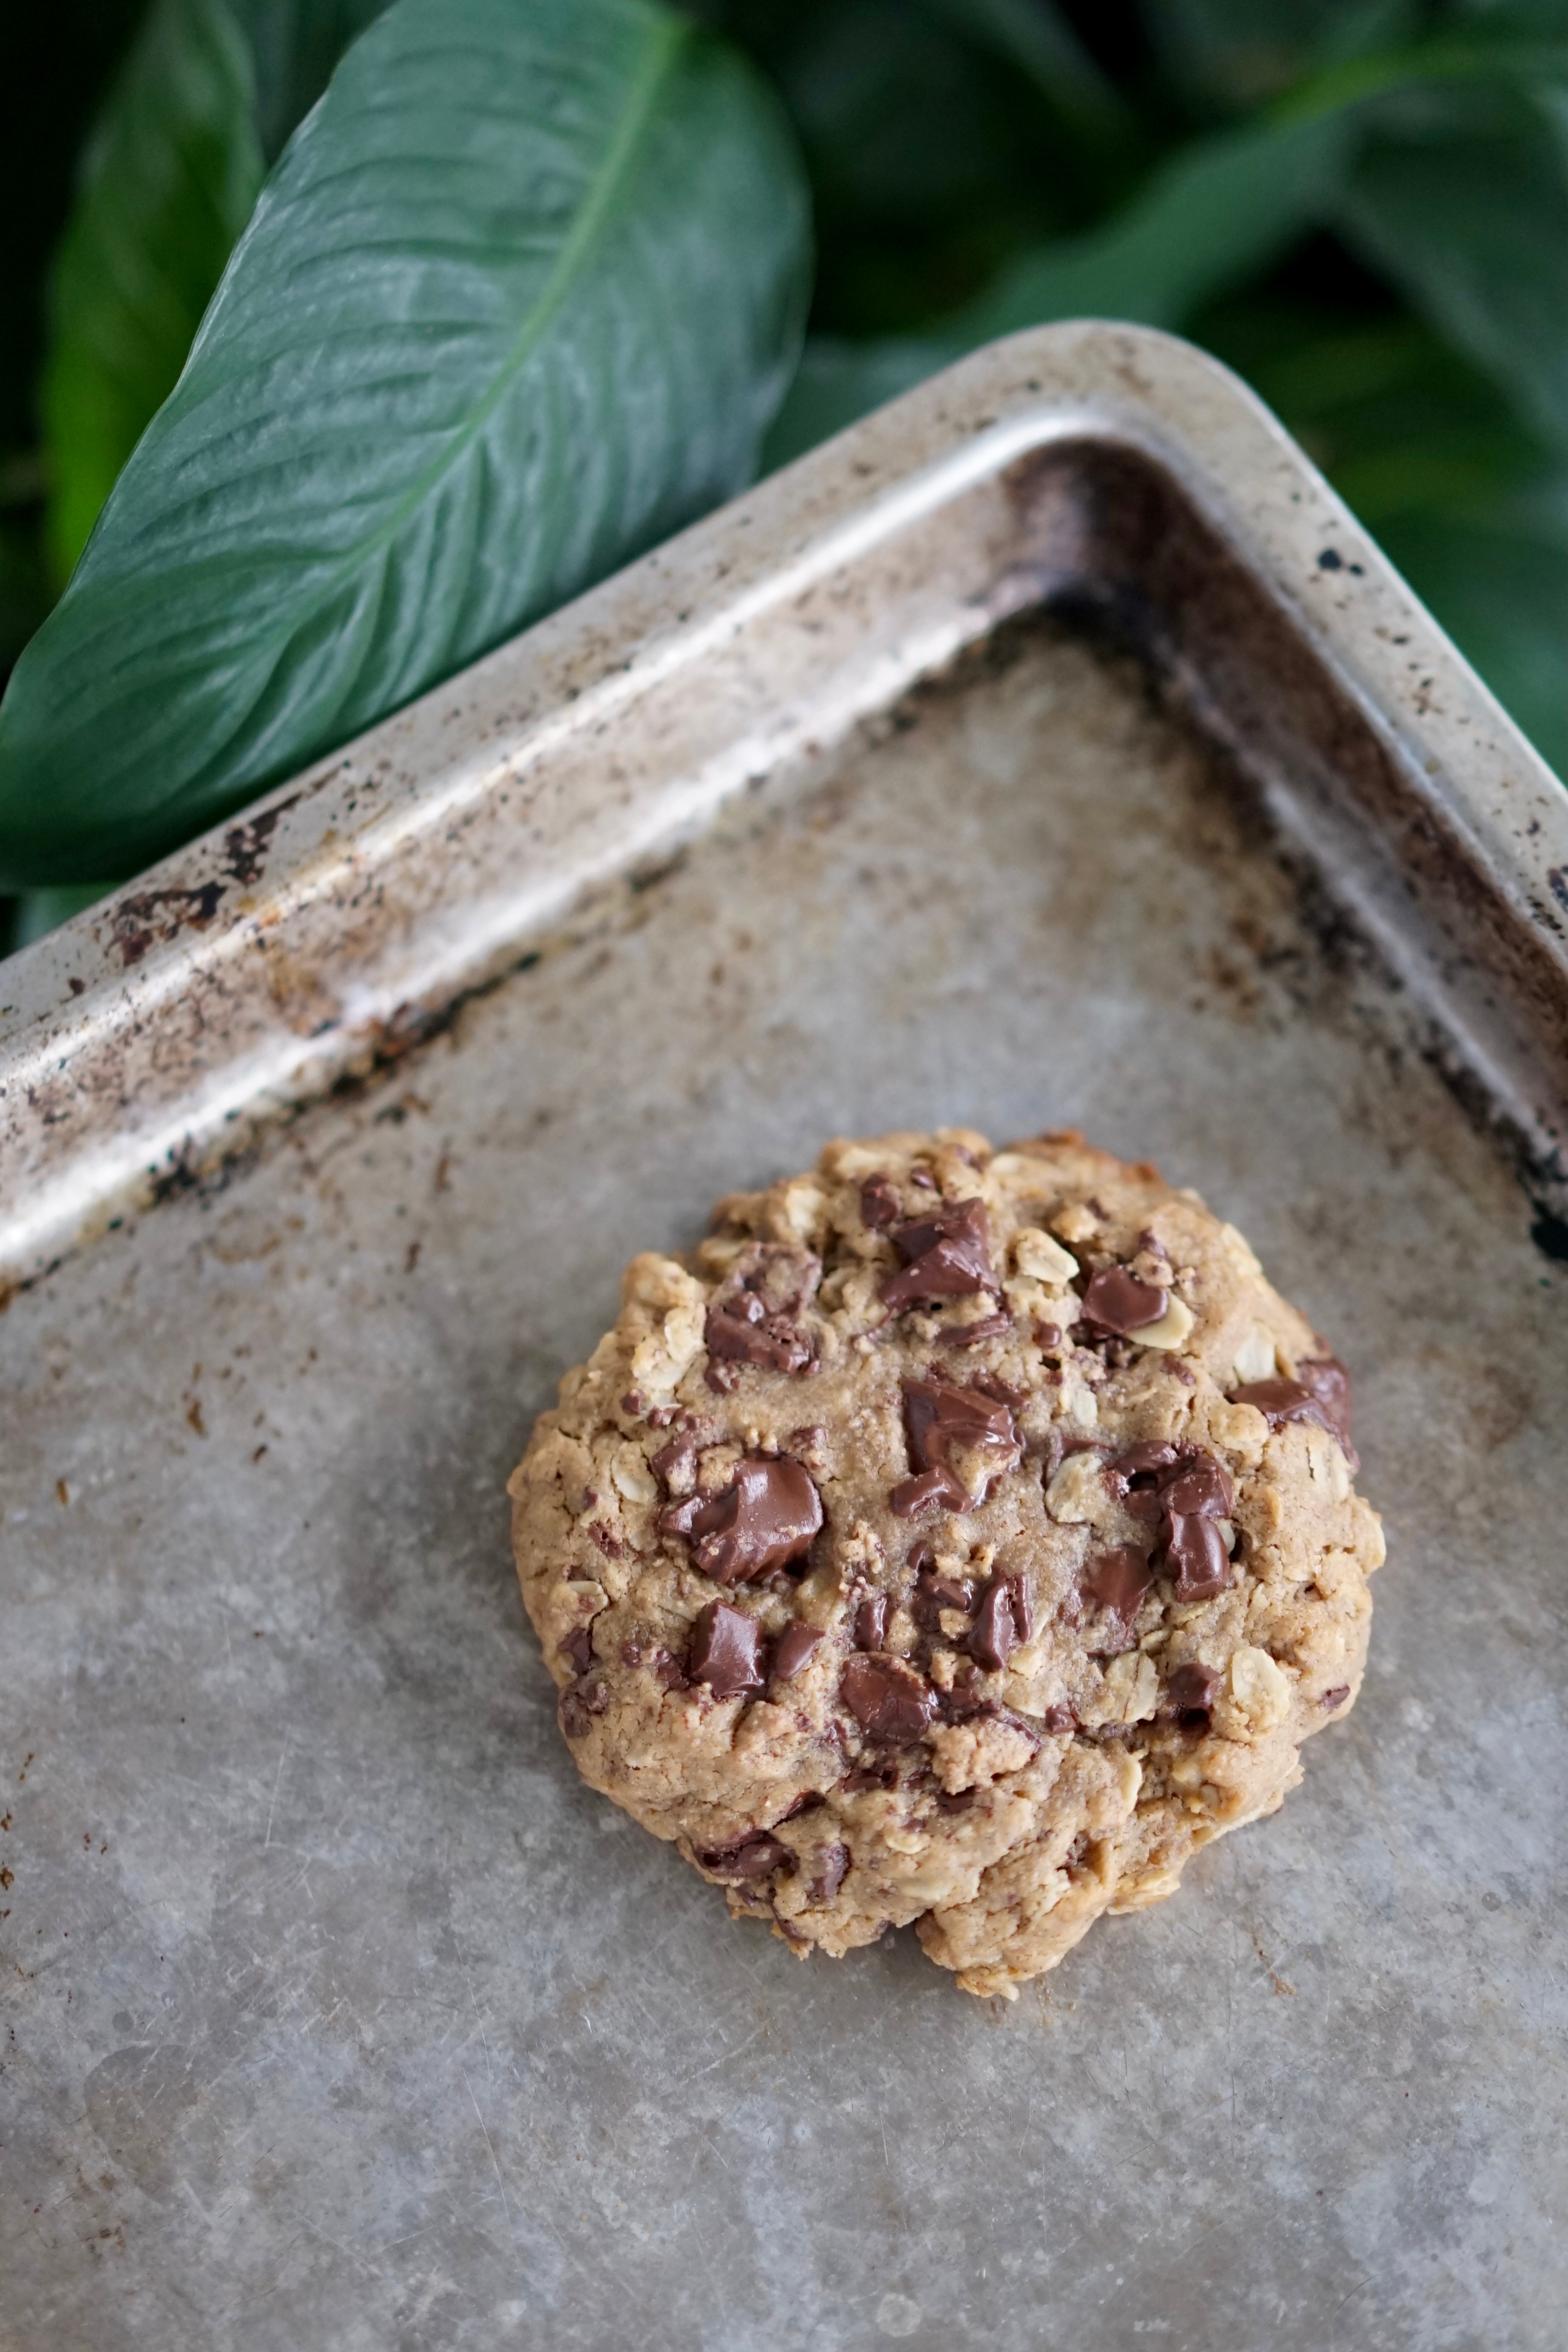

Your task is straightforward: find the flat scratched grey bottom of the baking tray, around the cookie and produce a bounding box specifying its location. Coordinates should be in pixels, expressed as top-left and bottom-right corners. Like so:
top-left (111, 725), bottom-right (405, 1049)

top-left (0, 626), bottom-right (1568, 2352)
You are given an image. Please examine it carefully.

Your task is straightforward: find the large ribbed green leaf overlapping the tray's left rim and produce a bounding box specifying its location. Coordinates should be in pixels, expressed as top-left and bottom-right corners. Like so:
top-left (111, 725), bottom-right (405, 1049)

top-left (0, 0), bottom-right (809, 884)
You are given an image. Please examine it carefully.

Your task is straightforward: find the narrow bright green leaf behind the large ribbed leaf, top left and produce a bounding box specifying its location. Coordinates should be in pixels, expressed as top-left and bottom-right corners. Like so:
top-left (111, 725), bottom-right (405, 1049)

top-left (43, 0), bottom-right (261, 581)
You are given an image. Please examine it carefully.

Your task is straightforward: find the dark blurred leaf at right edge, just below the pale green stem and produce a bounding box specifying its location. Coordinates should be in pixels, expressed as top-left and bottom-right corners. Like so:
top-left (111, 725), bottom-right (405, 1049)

top-left (1340, 94), bottom-right (1568, 444)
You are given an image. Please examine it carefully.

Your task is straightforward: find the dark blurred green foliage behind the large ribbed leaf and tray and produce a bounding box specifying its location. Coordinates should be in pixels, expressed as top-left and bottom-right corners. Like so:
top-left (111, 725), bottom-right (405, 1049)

top-left (0, 0), bottom-right (1568, 936)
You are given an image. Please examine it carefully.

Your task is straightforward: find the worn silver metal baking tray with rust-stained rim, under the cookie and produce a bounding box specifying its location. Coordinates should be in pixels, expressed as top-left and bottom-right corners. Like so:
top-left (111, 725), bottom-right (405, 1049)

top-left (0, 325), bottom-right (1568, 2352)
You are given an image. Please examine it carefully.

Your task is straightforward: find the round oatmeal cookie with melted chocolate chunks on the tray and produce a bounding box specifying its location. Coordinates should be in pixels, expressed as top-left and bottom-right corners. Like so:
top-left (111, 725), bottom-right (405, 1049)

top-left (508, 1129), bottom-right (1382, 1994)
